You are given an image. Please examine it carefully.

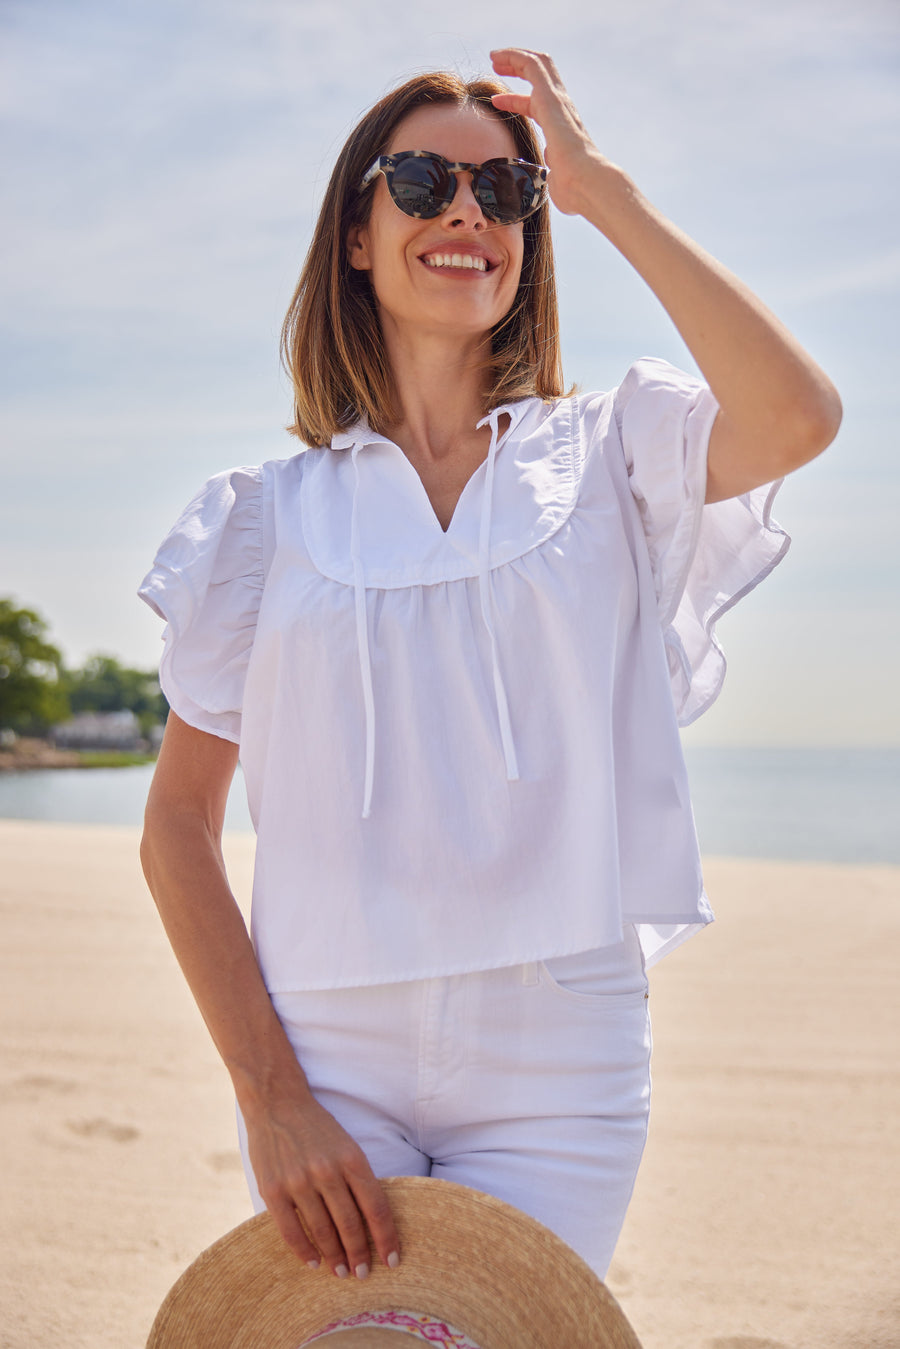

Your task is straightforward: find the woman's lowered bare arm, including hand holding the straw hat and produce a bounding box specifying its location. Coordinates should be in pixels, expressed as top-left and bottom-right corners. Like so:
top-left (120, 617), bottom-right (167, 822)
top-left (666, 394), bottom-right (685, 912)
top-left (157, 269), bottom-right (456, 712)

top-left (140, 712), bottom-right (399, 1278)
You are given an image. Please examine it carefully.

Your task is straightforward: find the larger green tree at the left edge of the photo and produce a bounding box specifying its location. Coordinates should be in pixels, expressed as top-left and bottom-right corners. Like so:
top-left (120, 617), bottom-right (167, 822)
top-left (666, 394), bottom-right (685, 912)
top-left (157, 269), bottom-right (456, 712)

top-left (0, 599), bottom-right (69, 735)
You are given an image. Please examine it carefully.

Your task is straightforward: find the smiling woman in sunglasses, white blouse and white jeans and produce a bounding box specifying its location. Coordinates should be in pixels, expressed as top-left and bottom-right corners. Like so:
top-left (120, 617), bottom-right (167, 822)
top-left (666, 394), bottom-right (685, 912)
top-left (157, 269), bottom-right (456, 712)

top-left (142, 50), bottom-right (841, 1295)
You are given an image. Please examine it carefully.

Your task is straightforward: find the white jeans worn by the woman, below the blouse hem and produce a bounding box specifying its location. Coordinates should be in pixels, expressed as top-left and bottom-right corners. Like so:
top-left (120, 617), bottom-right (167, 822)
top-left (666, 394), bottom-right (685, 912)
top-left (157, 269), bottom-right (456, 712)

top-left (239, 928), bottom-right (650, 1278)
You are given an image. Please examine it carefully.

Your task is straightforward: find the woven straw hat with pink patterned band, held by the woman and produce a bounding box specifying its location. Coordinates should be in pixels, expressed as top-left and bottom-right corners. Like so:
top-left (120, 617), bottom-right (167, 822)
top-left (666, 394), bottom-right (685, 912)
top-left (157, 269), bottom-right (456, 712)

top-left (147, 1176), bottom-right (641, 1349)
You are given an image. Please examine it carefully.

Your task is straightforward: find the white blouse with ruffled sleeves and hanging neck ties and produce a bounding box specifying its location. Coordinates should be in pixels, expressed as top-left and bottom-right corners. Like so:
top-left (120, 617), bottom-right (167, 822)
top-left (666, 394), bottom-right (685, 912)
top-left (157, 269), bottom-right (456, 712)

top-left (140, 360), bottom-right (789, 993)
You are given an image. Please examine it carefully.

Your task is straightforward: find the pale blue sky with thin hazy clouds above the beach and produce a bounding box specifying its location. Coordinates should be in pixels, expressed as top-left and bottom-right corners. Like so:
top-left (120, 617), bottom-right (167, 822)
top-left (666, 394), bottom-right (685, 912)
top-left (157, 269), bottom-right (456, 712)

top-left (0, 0), bottom-right (900, 746)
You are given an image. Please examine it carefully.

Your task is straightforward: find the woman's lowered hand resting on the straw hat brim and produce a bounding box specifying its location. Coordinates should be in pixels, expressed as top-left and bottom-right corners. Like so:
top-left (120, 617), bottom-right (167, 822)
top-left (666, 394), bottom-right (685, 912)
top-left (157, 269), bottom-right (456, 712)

top-left (243, 1074), bottom-right (399, 1279)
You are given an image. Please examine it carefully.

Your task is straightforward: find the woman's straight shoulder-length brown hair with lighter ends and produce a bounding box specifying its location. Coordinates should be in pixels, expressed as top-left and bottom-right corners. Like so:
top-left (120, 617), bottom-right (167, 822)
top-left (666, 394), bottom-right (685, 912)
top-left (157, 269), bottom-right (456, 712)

top-left (281, 71), bottom-right (564, 445)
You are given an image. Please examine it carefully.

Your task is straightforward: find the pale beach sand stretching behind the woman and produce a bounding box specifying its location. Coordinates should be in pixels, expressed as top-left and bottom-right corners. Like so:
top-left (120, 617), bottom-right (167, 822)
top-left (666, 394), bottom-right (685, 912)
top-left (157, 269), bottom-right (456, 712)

top-left (0, 820), bottom-right (900, 1349)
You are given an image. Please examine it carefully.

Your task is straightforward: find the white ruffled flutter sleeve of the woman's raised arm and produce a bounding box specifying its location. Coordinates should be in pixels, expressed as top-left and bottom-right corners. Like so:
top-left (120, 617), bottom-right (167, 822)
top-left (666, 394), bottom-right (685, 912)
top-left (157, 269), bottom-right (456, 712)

top-left (615, 359), bottom-right (791, 726)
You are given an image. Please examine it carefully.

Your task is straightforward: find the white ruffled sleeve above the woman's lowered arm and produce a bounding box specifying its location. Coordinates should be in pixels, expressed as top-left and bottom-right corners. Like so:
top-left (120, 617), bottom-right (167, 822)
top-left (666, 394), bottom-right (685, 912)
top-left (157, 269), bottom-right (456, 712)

top-left (138, 468), bottom-right (263, 743)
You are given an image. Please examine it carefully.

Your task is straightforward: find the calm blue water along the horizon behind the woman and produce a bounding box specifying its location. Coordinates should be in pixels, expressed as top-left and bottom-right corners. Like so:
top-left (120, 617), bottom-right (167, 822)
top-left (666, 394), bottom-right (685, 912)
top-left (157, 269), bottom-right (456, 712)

top-left (0, 747), bottom-right (900, 865)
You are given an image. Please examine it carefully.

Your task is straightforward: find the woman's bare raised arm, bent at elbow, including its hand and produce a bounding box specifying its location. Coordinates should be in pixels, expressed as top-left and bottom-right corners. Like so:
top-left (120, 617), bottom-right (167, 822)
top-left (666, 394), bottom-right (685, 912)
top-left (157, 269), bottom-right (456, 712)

top-left (491, 47), bottom-right (841, 502)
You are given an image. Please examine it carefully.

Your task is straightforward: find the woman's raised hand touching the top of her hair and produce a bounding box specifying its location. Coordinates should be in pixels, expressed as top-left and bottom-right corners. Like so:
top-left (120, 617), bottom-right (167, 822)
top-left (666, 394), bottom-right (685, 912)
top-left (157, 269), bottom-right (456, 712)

top-left (491, 47), bottom-right (606, 216)
